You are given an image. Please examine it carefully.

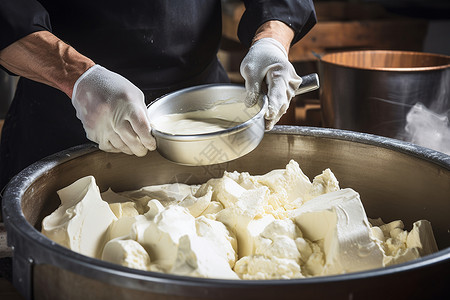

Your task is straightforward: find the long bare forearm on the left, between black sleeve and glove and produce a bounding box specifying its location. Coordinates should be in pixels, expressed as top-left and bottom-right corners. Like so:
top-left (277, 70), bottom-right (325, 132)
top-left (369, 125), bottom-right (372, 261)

top-left (0, 31), bottom-right (94, 97)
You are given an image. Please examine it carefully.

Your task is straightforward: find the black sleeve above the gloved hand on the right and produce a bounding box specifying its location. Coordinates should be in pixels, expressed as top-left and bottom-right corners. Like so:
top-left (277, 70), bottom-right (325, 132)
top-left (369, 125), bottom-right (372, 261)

top-left (238, 0), bottom-right (317, 47)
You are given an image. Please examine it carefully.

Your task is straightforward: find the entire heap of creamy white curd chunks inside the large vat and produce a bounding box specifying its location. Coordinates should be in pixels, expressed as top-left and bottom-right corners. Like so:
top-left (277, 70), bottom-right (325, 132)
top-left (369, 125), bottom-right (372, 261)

top-left (42, 160), bottom-right (438, 280)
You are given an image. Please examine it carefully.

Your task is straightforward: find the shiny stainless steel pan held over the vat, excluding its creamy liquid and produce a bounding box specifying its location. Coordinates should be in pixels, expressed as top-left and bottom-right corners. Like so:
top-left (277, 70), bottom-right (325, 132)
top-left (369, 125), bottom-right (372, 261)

top-left (148, 84), bottom-right (267, 166)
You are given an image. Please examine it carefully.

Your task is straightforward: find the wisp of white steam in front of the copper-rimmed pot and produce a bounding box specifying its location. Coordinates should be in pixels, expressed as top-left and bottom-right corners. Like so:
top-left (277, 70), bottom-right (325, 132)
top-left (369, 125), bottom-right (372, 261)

top-left (404, 101), bottom-right (450, 155)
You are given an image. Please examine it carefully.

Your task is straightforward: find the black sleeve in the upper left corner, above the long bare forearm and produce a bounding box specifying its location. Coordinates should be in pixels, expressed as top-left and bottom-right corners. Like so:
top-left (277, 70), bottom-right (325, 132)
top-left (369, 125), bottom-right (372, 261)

top-left (0, 0), bottom-right (51, 50)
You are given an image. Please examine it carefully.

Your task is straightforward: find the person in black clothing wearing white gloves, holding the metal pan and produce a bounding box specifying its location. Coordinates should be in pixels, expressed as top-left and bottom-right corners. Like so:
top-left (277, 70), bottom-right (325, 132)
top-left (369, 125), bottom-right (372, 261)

top-left (0, 0), bottom-right (316, 195)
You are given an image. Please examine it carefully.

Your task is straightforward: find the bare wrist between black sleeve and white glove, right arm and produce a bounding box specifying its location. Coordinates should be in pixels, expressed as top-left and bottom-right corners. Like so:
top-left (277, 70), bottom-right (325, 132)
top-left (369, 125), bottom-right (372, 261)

top-left (253, 20), bottom-right (294, 53)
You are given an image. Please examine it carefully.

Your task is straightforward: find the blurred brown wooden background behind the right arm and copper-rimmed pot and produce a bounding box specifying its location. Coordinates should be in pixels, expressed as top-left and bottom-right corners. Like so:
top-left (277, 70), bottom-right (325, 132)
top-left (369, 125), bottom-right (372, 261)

top-left (219, 0), bottom-right (450, 127)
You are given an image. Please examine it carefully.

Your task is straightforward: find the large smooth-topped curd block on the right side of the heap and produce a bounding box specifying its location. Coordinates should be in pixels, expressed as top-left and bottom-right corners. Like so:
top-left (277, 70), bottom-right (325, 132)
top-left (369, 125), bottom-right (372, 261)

top-left (292, 189), bottom-right (383, 275)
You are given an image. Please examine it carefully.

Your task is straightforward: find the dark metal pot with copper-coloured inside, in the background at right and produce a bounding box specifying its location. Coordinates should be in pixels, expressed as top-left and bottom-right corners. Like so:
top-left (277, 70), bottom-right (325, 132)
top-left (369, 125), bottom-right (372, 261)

top-left (319, 50), bottom-right (450, 139)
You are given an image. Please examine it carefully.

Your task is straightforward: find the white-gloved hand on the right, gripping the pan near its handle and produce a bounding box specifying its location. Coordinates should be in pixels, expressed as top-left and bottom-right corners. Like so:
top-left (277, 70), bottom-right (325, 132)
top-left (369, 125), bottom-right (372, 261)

top-left (240, 38), bottom-right (302, 130)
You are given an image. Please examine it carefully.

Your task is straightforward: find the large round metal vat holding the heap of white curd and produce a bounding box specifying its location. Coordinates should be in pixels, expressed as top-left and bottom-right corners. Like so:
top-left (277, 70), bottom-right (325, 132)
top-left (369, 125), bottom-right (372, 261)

top-left (3, 126), bottom-right (450, 300)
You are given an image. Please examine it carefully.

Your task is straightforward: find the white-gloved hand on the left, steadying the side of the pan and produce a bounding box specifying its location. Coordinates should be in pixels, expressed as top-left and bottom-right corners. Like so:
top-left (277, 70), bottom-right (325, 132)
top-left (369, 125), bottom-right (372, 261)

top-left (72, 65), bottom-right (156, 156)
